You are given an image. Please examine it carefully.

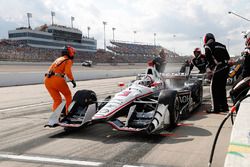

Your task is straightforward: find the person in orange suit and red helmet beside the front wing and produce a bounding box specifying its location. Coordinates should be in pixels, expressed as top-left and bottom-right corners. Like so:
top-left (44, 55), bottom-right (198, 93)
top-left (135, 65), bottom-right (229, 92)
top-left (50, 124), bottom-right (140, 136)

top-left (44, 46), bottom-right (76, 114)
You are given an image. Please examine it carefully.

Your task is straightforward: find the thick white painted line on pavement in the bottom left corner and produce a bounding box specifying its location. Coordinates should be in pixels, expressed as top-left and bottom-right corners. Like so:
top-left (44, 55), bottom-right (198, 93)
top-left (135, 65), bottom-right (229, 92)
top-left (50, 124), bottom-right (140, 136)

top-left (0, 154), bottom-right (102, 166)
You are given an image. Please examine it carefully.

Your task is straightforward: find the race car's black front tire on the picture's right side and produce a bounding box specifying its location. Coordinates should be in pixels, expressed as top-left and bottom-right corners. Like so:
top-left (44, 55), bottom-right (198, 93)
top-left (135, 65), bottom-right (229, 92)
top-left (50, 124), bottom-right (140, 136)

top-left (158, 90), bottom-right (180, 129)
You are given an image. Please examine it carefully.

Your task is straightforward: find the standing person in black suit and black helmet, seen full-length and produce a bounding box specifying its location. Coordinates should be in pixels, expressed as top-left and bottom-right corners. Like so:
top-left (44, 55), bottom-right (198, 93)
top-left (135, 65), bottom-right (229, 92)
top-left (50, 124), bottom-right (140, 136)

top-left (204, 33), bottom-right (230, 113)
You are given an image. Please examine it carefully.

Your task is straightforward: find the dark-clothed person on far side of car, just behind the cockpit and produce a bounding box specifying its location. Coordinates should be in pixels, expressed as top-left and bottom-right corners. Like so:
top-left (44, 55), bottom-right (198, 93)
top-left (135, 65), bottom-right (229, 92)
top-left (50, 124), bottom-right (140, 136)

top-left (152, 49), bottom-right (167, 73)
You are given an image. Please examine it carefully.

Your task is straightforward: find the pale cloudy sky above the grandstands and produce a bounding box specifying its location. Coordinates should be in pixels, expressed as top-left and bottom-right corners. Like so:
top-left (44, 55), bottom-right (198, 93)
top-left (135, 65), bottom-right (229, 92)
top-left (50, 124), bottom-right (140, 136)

top-left (0, 0), bottom-right (250, 55)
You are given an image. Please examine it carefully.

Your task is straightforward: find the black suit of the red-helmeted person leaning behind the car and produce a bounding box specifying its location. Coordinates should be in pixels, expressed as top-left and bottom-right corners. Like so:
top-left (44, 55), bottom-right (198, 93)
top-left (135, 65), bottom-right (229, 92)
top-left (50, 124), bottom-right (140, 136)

top-left (190, 54), bottom-right (207, 74)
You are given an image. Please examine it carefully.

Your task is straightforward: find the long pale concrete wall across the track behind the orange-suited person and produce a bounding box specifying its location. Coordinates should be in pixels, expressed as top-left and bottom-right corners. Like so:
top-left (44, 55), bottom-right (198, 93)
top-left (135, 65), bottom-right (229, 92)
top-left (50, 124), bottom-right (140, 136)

top-left (0, 61), bottom-right (180, 87)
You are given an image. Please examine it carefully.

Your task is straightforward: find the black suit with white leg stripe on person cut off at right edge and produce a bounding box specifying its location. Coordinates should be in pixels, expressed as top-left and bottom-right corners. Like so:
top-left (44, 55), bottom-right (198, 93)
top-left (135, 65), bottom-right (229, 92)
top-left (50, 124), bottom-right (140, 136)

top-left (230, 46), bottom-right (250, 103)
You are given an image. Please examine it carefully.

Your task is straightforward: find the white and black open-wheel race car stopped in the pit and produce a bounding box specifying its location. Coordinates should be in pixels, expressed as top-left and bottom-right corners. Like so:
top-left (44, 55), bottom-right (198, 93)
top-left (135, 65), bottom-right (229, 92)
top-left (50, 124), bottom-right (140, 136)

top-left (47, 67), bottom-right (203, 134)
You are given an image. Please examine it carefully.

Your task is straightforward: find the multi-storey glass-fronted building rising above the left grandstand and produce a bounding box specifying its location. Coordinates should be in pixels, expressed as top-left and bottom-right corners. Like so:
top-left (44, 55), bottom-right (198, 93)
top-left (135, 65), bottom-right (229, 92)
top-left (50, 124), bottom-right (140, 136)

top-left (8, 24), bottom-right (97, 52)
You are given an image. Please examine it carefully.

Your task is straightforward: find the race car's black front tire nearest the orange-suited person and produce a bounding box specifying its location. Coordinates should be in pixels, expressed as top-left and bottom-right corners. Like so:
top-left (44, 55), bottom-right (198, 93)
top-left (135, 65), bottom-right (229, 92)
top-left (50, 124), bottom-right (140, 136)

top-left (73, 90), bottom-right (97, 107)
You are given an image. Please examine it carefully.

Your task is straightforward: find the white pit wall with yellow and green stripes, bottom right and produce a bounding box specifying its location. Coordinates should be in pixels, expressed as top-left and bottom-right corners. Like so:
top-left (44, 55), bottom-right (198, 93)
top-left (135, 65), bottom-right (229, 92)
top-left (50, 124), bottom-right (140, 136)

top-left (224, 92), bottom-right (250, 167)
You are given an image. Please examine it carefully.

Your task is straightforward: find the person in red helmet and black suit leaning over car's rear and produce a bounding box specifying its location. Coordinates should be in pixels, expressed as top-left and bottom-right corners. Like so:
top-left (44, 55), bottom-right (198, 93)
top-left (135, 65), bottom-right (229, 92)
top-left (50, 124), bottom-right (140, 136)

top-left (189, 48), bottom-right (207, 74)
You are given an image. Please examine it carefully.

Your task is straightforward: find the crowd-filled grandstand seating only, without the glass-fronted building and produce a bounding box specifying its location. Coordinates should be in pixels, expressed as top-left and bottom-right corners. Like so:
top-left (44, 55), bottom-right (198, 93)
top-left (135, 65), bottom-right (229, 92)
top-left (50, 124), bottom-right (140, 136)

top-left (0, 39), bottom-right (189, 65)
